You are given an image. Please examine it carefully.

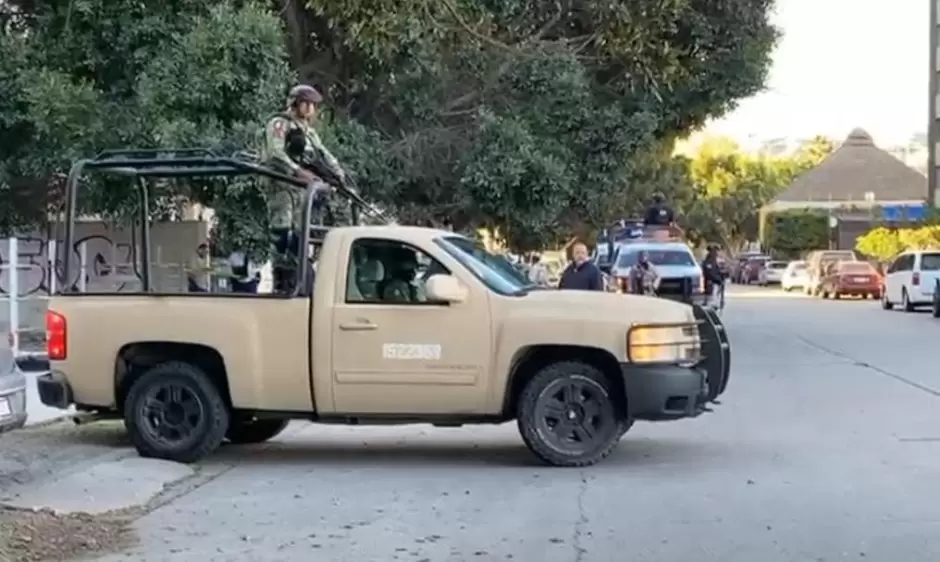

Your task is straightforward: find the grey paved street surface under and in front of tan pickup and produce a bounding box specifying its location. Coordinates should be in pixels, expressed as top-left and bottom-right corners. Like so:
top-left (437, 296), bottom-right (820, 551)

top-left (0, 288), bottom-right (940, 562)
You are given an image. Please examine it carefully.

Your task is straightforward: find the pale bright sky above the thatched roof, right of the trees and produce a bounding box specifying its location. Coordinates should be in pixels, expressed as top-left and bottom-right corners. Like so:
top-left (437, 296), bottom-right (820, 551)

top-left (707, 0), bottom-right (930, 146)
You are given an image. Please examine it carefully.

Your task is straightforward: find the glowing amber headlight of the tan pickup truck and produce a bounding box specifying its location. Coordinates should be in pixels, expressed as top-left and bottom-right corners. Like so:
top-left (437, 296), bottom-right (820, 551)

top-left (627, 323), bottom-right (702, 364)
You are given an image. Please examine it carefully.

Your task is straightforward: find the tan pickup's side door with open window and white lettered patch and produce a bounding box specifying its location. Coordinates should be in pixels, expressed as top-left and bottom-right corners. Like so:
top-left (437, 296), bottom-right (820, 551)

top-left (332, 234), bottom-right (492, 414)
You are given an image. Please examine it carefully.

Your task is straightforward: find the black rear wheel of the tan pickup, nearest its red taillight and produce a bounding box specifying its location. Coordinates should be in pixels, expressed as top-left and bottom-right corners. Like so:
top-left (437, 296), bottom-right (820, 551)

top-left (124, 361), bottom-right (229, 463)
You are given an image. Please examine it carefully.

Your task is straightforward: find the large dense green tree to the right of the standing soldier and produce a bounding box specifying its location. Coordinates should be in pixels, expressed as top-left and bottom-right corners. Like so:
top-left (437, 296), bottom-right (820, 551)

top-left (282, 0), bottom-right (776, 250)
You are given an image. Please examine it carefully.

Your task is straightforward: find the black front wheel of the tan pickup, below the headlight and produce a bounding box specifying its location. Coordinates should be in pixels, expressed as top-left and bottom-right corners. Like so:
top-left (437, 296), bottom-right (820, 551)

top-left (516, 361), bottom-right (629, 467)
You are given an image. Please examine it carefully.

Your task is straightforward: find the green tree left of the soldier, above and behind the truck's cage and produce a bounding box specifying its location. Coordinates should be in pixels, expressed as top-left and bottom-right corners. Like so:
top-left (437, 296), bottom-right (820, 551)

top-left (0, 0), bottom-right (291, 249)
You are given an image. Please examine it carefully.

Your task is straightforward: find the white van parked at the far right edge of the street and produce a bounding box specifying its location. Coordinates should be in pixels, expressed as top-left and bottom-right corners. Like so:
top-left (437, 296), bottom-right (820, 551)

top-left (881, 250), bottom-right (940, 312)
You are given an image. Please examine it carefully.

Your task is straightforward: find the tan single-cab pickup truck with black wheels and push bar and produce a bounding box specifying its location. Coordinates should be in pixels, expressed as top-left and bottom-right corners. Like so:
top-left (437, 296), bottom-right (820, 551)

top-left (38, 148), bottom-right (730, 466)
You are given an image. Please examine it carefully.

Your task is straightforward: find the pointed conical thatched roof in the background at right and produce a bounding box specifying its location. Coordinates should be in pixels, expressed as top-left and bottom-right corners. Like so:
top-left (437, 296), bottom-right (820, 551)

top-left (773, 129), bottom-right (927, 204)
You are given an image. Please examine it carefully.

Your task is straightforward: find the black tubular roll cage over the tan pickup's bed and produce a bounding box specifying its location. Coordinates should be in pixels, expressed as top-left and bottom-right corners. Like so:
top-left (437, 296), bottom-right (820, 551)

top-left (62, 148), bottom-right (384, 294)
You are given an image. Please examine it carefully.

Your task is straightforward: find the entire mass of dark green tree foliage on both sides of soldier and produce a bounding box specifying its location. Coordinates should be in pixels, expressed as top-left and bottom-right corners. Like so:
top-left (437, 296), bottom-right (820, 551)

top-left (0, 0), bottom-right (777, 250)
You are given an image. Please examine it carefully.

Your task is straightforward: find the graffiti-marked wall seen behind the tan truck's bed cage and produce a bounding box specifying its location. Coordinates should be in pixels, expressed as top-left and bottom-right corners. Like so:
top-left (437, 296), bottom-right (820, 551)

top-left (0, 221), bottom-right (207, 297)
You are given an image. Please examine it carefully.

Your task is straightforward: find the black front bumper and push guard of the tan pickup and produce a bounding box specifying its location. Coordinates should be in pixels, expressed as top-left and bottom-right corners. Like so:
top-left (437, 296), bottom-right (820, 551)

top-left (620, 306), bottom-right (731, 421)
